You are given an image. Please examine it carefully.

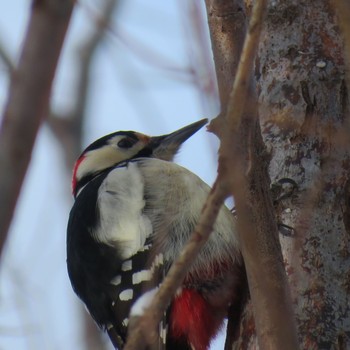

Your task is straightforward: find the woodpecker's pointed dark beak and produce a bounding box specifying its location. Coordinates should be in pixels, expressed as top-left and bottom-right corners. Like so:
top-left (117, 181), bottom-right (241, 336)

top-left (148, 119), bottom-right (208, 160)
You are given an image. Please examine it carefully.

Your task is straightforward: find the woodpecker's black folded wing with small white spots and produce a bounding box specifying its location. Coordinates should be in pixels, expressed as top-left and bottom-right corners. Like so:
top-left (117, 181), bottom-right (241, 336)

top-left (67, 169), bottom-right (168, 348)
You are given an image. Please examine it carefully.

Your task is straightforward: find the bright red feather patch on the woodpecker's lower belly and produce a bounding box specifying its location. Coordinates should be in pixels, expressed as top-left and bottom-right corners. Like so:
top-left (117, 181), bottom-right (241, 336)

top-left (170, 289), bottom-right (223, 350)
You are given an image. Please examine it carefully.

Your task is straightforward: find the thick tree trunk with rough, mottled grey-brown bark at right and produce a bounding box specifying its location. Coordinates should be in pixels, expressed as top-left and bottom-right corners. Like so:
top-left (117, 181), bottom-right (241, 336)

top-left (235, 0), bottom-right (350, 349)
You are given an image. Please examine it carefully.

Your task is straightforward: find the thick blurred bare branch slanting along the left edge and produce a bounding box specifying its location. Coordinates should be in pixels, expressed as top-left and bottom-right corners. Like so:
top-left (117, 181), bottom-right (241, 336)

top-left (0, 0), bottom-right (74, 258)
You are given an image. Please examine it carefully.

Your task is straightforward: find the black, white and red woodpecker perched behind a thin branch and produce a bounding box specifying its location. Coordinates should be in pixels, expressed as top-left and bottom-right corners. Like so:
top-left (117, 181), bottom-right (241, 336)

top-left (67, 119), bottom-right (242, 350)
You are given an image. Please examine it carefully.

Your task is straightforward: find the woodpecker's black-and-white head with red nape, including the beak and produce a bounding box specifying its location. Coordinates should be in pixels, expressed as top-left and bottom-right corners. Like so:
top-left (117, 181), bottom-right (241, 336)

top-left (72, 119), bottom-right (207, 197)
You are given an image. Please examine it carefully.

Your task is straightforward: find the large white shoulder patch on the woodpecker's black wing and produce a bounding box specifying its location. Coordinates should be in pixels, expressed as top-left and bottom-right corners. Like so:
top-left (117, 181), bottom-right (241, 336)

top-left (93, 163), bottom-right (152, 259)
